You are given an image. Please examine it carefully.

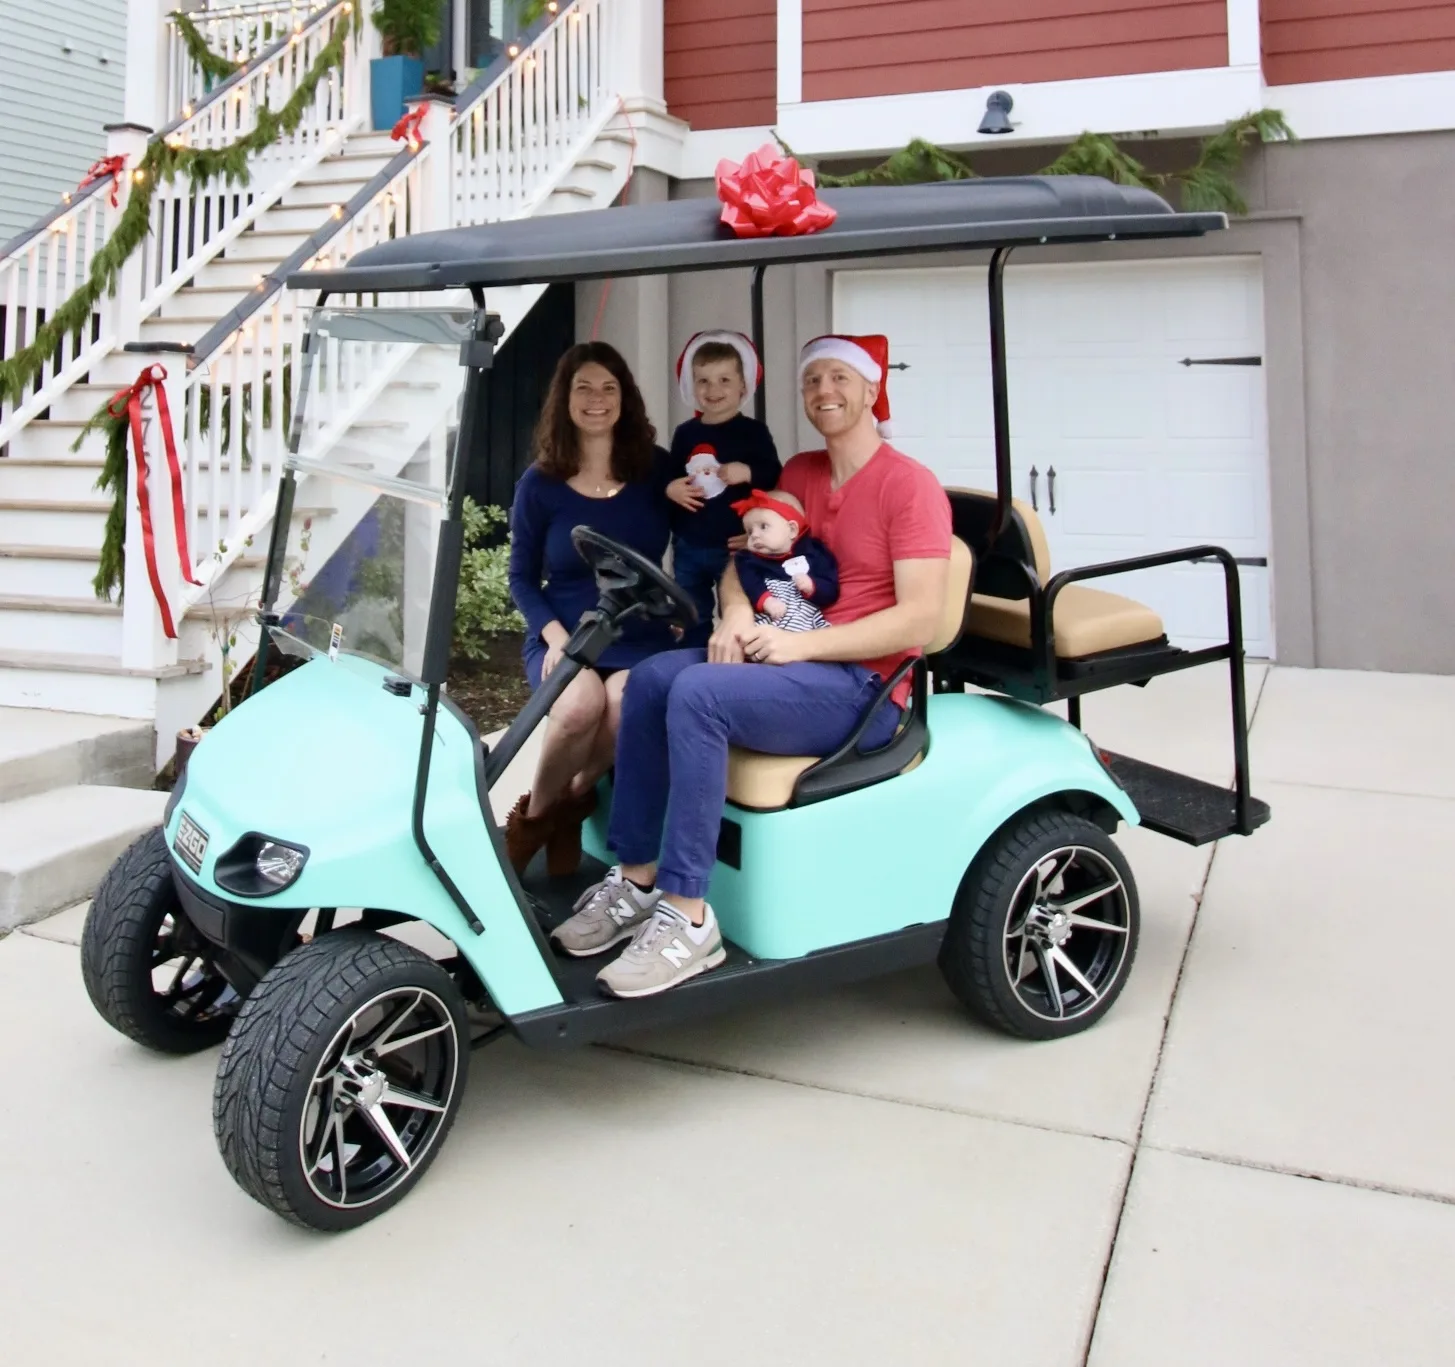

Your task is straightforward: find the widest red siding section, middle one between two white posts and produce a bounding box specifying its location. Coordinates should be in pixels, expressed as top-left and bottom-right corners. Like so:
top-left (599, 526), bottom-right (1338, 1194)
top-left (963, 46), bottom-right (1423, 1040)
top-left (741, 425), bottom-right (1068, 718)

top-left (803, 0), bottom-right (1228, 100)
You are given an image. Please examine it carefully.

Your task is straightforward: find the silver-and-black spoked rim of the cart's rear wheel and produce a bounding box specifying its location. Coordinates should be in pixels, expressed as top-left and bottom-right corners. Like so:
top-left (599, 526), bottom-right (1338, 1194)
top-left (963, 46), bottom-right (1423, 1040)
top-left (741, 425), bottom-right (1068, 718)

top-left (1004, 845), bottom-right (1131, 1021)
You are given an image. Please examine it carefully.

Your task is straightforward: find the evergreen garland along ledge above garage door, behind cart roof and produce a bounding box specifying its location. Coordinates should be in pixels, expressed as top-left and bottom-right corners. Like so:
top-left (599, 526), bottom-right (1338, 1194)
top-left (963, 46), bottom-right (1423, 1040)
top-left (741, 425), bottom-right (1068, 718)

top-left (791, 109), bottom-right (1296, 214)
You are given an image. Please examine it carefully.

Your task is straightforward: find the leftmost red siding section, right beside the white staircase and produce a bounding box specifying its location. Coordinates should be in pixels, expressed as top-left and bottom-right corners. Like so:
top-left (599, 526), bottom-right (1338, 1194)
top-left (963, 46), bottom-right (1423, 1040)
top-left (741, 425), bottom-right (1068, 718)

top-left (663, 0), bottom-right (778, 128)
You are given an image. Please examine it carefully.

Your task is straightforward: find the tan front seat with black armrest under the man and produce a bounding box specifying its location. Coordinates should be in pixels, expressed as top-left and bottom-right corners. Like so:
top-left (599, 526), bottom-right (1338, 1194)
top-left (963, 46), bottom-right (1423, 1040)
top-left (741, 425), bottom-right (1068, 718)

top-left (728, 537), bottom-right (975, 811)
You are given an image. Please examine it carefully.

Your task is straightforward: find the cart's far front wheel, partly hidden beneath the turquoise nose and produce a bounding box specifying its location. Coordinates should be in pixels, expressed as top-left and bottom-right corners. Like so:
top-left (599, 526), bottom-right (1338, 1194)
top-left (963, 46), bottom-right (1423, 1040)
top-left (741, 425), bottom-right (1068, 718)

top-left (81, 826), bottom-right (237, 1054)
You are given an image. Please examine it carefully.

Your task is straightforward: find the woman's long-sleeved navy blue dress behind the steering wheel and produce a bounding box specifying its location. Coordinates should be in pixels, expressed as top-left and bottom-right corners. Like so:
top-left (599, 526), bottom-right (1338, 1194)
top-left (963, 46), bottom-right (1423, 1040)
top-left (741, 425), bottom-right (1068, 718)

top-left (511, 449), bottom-right (677, 688)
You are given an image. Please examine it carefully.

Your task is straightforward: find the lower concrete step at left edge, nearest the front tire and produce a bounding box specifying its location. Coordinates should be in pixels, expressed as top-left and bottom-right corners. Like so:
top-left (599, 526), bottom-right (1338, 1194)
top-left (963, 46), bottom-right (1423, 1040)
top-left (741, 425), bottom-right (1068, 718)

top-left (0, 785), bottom-right (167, 928)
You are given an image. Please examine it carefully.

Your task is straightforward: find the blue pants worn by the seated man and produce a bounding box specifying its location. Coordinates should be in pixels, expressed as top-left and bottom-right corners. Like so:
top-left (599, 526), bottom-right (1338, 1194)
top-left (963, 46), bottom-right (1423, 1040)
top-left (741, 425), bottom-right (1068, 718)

top-left (607, 650), bottom-right (901, 897)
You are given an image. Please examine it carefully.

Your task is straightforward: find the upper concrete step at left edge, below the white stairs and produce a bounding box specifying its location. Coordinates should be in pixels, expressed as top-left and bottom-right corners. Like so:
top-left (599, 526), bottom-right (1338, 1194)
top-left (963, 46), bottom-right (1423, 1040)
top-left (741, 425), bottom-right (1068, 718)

top-left (0, 707), bottom-right (156, 801)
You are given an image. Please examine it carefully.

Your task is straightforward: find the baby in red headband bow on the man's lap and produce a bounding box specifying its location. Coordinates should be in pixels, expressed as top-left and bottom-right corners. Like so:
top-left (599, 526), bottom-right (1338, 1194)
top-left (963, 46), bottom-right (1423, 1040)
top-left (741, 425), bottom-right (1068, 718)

top-left (732, 489), bottom-right (838, 631)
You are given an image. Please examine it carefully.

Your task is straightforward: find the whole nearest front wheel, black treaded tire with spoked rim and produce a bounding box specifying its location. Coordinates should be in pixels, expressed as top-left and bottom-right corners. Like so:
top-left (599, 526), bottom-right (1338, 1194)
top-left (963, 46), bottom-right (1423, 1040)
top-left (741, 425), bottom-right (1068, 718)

top-left (212, 929), bottom-right (470, 1232)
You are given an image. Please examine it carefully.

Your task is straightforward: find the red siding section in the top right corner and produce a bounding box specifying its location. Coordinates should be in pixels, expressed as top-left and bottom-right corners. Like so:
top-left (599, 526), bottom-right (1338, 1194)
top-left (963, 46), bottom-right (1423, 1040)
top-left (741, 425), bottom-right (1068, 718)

top-left (1261, 0), bottom-right (1455, 86)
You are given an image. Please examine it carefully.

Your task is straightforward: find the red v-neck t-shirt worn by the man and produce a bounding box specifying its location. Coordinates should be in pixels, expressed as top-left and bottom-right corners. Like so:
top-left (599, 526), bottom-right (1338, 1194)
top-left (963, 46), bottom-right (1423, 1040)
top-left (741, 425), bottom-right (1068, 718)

top-left (778, 444), bottom-right (952, 707)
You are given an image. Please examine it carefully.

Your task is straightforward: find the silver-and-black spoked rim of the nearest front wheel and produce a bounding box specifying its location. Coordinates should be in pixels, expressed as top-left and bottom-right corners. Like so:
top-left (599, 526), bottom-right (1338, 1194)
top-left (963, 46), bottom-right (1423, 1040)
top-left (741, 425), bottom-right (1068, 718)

top-left (298, 987), bottom-right (460, 1210)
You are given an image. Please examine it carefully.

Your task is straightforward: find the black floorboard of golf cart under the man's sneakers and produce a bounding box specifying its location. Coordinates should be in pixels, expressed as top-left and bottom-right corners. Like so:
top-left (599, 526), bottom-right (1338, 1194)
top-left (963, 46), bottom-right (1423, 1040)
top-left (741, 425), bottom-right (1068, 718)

top-left (511, 857), bottom-right (946, 1049)
